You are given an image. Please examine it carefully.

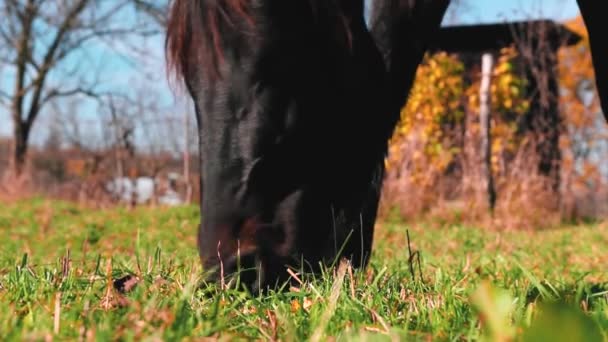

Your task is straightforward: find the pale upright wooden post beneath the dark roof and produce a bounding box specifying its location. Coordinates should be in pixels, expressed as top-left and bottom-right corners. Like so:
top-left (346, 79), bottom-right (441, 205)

top-left (479, 53), bottom-right (496, 213)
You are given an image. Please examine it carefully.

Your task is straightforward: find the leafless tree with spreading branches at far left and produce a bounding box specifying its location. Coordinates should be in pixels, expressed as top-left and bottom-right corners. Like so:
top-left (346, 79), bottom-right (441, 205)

top-left (0, 0), bottom-right (156, 176)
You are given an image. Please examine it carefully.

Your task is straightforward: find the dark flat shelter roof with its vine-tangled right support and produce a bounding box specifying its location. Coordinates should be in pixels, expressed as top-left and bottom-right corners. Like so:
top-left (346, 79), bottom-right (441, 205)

top-left (430, 20), bottom-right (582, 191)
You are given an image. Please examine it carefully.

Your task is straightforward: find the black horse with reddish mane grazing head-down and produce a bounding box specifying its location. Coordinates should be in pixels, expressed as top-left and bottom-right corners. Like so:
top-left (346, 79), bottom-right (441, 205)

top-left (166, 0), bottom-right (606, 289)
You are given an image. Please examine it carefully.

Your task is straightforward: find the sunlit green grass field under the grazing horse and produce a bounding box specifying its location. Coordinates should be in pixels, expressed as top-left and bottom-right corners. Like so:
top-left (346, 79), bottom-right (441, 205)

top-left (0, 199), bottom-right (608, 341)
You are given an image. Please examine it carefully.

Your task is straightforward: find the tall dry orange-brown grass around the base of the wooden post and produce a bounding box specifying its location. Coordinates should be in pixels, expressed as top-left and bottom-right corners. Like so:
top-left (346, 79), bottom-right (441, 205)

top-left (380, 134), bottom-right (608, 230)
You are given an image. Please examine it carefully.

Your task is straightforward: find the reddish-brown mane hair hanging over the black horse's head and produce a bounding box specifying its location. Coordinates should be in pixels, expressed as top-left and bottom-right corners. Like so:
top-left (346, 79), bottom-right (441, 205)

top-left (165, 0), bottom-right (255, 85)
